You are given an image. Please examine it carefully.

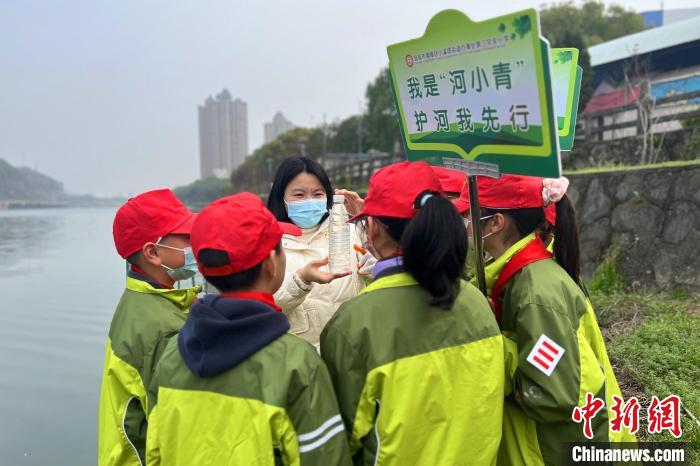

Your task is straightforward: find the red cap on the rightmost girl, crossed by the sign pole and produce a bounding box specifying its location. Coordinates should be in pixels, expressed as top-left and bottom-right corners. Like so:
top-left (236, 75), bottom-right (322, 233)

top-left (452, 175), bottom-right (544, 213)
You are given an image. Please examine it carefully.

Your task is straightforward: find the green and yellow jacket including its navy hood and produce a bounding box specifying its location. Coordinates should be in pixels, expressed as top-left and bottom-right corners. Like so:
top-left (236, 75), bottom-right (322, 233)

top-left (146, 295), bottom-right (351, 466)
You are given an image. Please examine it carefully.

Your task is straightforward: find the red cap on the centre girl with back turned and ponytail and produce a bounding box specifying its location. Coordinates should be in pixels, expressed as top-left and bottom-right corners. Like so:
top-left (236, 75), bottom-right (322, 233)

top-left (349, 162), bottom-right (443, 222)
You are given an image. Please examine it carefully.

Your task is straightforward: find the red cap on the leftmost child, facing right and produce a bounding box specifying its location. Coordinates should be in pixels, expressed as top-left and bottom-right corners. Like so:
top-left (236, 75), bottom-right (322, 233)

top-left (112, 189), bottom-right (196, 259)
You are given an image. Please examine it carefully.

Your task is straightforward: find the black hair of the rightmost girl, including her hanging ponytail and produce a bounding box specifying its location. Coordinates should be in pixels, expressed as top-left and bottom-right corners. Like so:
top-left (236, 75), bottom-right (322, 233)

top-left (481, 195), bottom-right (582, 286)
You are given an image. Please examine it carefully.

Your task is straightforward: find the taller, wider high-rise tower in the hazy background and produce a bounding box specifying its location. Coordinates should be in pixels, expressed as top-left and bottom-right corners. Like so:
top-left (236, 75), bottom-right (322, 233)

top-left (199, 89), bottom-right (248, 178)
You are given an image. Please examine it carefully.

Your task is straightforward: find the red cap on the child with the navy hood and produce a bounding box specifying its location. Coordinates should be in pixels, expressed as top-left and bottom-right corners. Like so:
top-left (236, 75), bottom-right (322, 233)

top-left (190, 193), bottom-right (301, 277)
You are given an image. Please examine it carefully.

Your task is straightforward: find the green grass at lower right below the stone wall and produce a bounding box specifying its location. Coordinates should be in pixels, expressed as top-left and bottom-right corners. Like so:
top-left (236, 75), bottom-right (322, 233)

top-left (592, 291), bottom-right (700, 458)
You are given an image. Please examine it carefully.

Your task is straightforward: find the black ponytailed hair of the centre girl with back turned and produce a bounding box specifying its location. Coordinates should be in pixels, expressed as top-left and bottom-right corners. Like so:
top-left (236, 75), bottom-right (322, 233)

top-left (378, 191), bottom-right (469, 310)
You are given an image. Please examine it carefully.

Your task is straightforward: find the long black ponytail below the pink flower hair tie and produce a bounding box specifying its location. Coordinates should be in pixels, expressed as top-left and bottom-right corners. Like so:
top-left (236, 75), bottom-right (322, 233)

top-left (554, 195), bottom-right (582, 286)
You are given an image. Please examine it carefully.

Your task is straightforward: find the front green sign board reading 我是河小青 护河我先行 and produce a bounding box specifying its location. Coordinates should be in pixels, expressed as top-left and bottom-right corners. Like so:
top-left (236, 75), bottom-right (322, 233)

top-left (387, 9), bottom-right (561, 177)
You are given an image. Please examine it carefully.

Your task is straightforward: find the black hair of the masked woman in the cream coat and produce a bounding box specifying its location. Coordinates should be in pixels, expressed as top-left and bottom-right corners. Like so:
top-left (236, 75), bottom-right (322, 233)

top-left (267, 156), bottom-right (333, 223)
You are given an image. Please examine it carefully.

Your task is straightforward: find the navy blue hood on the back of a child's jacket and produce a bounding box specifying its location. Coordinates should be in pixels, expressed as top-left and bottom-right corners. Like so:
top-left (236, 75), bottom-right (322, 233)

top-left (177, 295), bottom-right (289, 377)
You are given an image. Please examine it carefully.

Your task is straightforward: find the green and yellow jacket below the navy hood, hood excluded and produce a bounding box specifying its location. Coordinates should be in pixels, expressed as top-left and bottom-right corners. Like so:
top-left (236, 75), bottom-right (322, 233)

top-left (146, 334), bottom-right (350, 466)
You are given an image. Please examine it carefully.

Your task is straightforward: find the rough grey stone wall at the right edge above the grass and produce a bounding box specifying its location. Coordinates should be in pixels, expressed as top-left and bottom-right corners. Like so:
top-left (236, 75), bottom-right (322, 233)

top-left (569, 165), bottom-right (700, 294)
